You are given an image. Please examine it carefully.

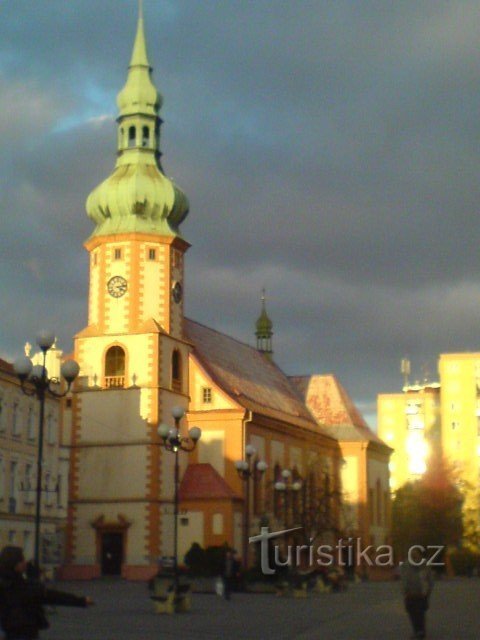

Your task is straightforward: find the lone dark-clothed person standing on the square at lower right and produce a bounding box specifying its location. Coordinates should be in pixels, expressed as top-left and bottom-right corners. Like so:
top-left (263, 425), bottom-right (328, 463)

top-left (400, 547), bottom-right (433, 638)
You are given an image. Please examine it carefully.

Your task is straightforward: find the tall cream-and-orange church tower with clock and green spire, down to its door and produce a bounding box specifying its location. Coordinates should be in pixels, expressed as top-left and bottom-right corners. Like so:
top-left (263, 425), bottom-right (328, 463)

top-left (64, 5), bottom-right (190, 578)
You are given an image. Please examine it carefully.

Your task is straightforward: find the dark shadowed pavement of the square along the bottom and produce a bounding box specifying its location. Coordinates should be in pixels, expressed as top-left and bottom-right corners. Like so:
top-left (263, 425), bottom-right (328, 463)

top-left (43, 578), bottom-right (480, 640)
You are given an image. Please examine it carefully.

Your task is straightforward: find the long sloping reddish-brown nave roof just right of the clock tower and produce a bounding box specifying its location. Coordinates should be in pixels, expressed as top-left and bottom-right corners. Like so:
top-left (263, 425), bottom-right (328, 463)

top-left (184, 319), bottom-right (327, 435)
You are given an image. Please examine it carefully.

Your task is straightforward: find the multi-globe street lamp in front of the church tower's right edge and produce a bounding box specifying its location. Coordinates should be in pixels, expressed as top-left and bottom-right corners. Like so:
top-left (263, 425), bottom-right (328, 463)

top-left (157, 407), bottom-right (202, 593)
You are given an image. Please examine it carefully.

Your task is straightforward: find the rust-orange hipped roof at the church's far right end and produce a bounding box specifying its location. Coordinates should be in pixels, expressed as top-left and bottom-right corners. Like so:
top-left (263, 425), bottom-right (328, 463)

top-left (290, 374), bottom-right (387, 447)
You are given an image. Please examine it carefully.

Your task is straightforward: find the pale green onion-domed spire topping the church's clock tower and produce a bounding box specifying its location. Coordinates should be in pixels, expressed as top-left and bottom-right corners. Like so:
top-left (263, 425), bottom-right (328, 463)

top-left (87, 1), bottom-right (189, 236)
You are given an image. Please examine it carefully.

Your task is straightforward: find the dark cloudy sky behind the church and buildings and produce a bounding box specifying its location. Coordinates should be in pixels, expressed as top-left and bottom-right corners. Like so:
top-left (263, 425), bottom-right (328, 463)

top-left (0, 0), bottom-right (480, 425)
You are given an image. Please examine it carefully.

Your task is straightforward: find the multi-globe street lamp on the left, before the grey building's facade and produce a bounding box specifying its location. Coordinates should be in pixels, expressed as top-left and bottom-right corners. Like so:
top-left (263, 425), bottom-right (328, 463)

top-left (13, 331), bottom-right (80, 576)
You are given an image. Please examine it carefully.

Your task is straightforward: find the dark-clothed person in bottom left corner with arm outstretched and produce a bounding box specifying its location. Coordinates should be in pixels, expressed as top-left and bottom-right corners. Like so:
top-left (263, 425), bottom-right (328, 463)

top-left (0, 546), bottom-right (93, 640)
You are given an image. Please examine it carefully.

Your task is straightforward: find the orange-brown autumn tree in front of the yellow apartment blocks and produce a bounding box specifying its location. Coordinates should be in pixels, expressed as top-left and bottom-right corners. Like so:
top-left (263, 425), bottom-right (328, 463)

top-left (392, 456), bottom-right (463, 557)
